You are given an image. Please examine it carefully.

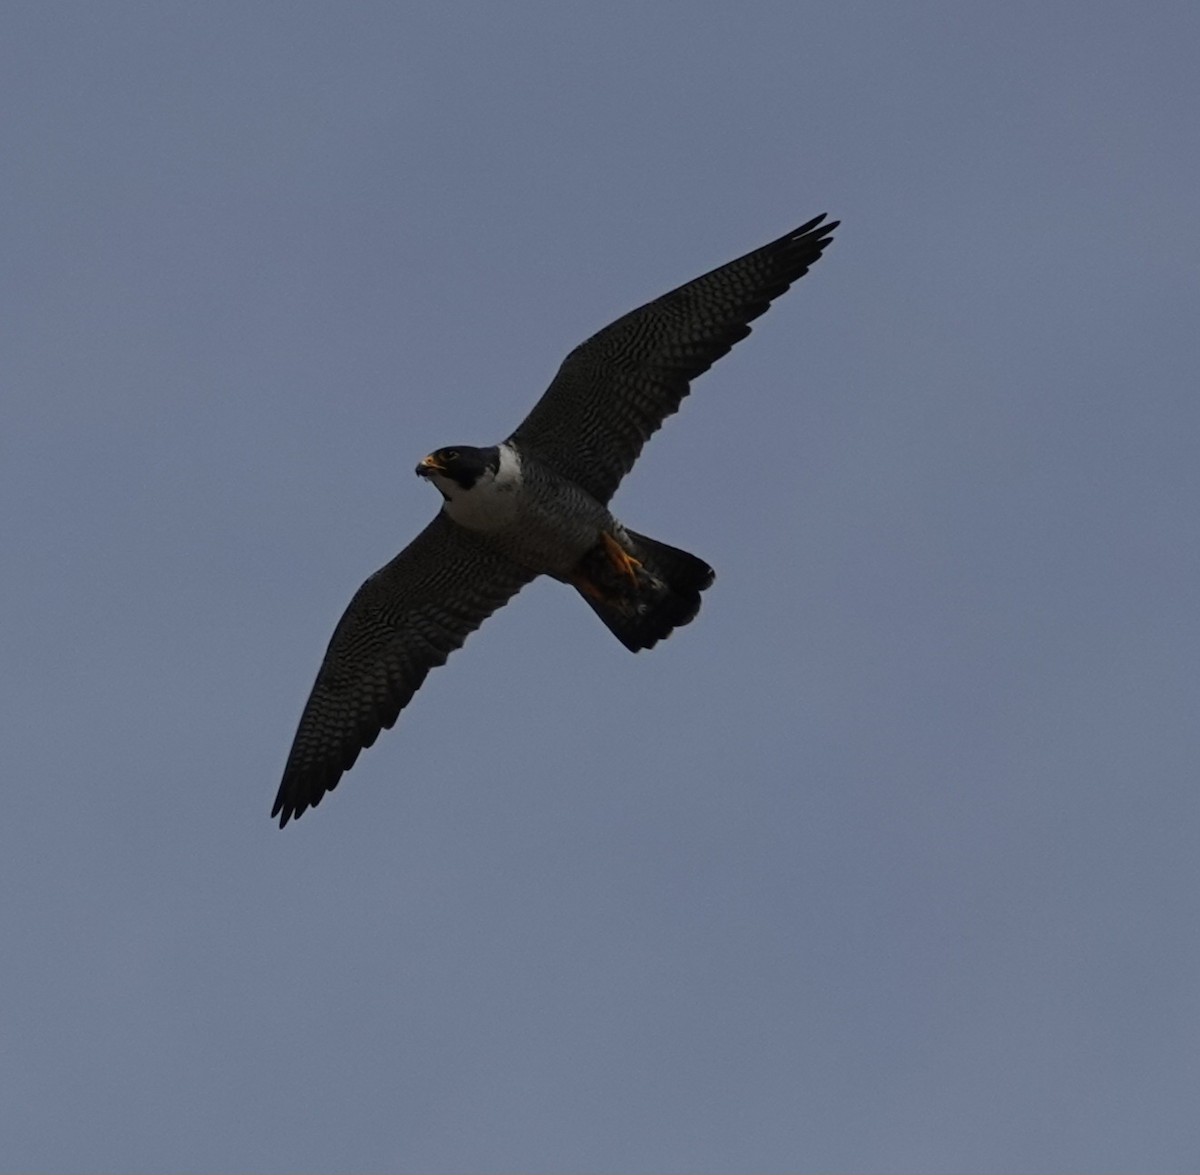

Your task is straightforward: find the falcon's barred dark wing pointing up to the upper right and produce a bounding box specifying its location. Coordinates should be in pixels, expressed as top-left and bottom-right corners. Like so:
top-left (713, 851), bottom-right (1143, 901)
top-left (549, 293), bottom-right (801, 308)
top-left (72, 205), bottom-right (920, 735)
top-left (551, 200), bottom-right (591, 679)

top-left (510, 216), bottom-right (839, 502)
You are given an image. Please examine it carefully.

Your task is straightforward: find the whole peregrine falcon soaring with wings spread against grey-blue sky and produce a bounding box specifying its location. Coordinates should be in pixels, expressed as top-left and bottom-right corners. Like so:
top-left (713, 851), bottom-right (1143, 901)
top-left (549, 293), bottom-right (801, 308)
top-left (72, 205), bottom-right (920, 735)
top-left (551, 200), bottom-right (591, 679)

top-left (271, 215), bottom-right (839, 828)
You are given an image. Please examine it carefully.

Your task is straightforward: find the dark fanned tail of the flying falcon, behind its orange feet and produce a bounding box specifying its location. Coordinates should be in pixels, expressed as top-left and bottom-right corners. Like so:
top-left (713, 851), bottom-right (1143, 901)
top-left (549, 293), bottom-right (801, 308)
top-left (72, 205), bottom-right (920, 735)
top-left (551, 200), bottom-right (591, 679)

top-left (576, 530), bottom-right (713, 653)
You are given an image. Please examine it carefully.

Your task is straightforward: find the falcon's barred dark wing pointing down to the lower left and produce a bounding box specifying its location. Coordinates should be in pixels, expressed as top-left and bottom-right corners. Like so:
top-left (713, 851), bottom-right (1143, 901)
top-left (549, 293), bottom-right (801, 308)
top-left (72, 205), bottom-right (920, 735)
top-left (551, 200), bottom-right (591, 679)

top-left (271, 512), bottom-right (534, 828)
